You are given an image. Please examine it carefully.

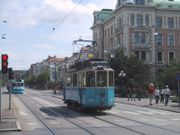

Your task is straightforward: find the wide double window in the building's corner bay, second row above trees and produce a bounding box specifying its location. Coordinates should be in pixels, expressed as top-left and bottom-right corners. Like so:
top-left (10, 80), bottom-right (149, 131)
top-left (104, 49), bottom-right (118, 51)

top-left (134, 32), bottom-right (146, 44)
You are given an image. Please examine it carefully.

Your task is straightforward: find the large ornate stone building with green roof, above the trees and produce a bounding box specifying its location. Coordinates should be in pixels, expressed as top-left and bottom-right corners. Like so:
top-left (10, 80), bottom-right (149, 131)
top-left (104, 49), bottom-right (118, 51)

top-left (91, 0), bottom-right (180, 71)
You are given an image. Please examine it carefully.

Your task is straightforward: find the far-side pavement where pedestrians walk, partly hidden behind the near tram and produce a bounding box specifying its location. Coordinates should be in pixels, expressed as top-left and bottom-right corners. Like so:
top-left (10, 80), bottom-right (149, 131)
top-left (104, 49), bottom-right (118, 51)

top-left (52, 93), bottom-right (180, 113)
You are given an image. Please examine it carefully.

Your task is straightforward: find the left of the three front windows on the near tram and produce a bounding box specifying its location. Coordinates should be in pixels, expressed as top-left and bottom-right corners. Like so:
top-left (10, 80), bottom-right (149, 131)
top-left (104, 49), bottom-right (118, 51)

top-left (86, 71), bottom-right (95, 87)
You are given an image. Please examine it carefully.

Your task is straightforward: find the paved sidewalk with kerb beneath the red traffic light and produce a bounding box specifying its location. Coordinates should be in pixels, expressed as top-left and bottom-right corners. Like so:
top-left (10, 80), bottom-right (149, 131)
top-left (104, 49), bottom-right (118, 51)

top-left (0, 88), bottom-right (21, 132)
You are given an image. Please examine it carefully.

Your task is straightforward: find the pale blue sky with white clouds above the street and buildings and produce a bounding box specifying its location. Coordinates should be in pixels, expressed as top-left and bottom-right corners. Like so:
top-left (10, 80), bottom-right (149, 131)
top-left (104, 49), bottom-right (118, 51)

top-left (0, 0), bottom-right (117, 70)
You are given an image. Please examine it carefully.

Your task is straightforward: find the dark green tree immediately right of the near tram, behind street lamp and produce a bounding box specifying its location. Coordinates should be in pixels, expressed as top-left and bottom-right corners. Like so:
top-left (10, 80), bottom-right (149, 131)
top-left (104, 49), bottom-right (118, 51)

top-left (110, 49), bottom-right (152, 87)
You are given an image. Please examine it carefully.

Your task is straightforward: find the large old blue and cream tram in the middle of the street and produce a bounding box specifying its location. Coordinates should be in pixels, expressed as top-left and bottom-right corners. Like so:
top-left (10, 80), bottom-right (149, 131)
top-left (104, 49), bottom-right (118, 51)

top-left (63, 60), bottom-right (114, 111)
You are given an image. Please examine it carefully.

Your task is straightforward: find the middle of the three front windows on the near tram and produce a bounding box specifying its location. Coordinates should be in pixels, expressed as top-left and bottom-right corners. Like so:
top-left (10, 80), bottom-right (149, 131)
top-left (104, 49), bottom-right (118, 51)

top-left (97, 71), bottom-right (107, 87)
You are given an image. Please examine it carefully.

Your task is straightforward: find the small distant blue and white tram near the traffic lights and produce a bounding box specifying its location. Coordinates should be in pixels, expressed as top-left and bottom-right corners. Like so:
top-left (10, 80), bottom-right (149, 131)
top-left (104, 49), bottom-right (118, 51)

top-left (11, 80), bottom-right (24, 94)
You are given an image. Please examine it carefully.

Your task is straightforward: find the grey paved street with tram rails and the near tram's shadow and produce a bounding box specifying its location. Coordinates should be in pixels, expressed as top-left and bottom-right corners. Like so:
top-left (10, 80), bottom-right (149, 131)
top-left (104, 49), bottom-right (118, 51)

top-left (0, 89), bottom-right (180, 135)
